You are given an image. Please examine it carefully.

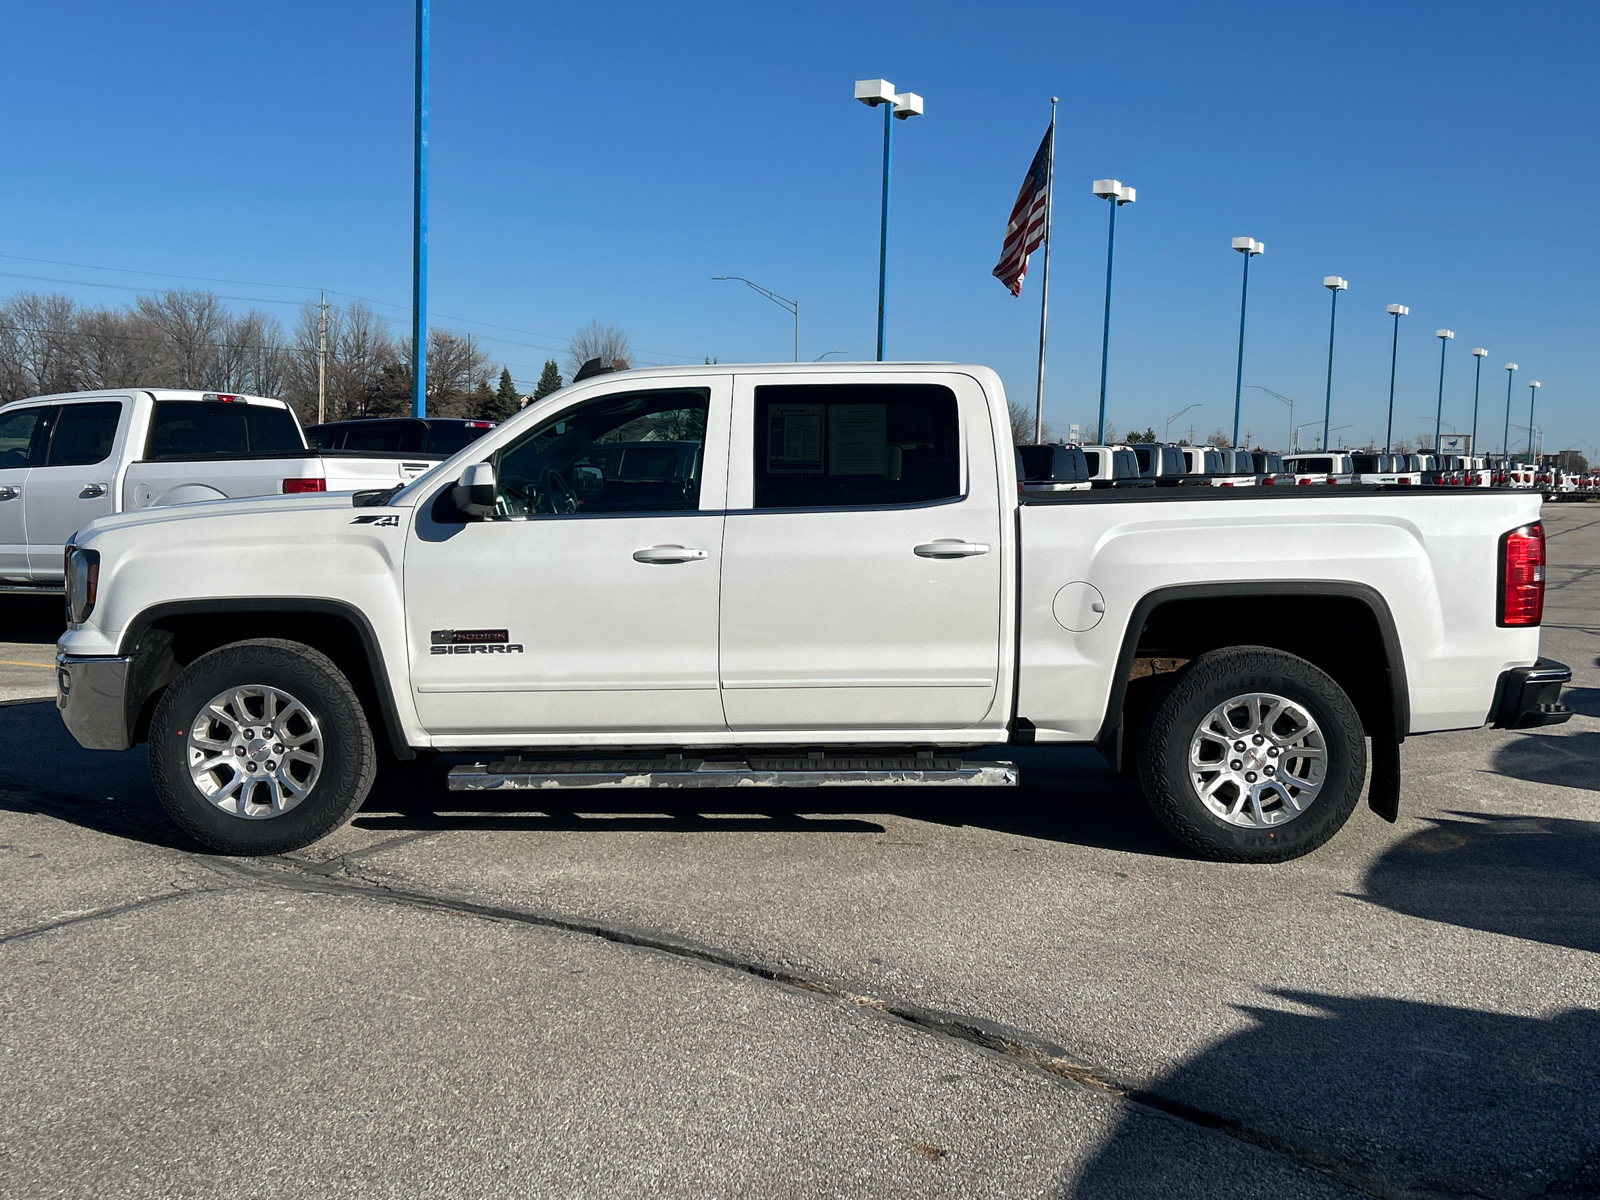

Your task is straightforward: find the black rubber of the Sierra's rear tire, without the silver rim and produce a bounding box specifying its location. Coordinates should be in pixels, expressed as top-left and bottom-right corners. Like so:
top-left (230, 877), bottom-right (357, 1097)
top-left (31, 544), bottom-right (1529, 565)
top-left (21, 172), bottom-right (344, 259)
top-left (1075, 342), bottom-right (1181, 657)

top-left (1138, 646), bottom-right (1366, 862)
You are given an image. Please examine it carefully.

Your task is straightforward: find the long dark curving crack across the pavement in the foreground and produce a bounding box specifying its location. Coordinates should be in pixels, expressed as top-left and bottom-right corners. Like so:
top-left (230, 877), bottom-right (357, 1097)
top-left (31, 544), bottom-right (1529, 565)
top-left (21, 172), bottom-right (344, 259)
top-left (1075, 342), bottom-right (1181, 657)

top-left (200, 856), bottom-right (1452, 1200)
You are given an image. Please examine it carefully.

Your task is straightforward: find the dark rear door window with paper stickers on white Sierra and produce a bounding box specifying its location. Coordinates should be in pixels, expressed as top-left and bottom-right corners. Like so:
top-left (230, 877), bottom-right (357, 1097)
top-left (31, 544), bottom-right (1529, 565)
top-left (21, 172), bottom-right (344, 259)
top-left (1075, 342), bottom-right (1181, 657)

top-left (755, 384), bottom-right (962, 509)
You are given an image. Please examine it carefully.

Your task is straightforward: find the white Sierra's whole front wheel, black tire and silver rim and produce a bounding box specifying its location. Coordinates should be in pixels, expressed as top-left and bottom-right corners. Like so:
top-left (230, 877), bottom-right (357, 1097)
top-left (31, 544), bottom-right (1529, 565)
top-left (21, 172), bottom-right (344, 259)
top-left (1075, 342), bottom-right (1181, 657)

top-left (150, 638), bottom-right (378, 854)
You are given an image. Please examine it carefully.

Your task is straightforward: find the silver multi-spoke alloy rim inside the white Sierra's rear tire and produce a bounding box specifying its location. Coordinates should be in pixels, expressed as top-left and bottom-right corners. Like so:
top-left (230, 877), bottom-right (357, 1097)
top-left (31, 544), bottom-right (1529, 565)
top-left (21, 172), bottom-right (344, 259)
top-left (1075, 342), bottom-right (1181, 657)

top-left (1189, 691), bottom-right (1328, 829)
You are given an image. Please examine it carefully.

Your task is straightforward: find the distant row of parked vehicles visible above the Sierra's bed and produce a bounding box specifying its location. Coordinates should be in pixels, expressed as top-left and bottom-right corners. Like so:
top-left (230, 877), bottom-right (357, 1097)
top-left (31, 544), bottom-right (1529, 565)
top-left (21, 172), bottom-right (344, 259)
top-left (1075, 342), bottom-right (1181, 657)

top-left (1018, 442), bottom-right (1580, 499)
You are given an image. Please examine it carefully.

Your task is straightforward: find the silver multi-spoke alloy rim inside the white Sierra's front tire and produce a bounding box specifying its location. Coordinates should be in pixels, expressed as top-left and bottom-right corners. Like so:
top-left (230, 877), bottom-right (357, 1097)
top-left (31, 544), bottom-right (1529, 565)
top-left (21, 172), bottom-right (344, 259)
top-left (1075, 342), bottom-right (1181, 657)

top-left (189, 683), bottom-right (323, 819)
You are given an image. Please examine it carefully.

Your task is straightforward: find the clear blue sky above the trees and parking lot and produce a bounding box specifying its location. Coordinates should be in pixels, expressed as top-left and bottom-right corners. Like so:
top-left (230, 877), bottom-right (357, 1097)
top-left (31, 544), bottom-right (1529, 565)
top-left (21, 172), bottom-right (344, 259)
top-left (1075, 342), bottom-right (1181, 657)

top-left (0, 0), bottom-right (1600, 458)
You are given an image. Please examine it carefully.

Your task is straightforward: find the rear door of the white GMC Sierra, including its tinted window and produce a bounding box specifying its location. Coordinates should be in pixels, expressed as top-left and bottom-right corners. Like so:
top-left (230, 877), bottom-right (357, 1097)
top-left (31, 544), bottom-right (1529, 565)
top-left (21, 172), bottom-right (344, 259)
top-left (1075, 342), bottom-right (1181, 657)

top-left (722, 371), bottom-right (1010, 733)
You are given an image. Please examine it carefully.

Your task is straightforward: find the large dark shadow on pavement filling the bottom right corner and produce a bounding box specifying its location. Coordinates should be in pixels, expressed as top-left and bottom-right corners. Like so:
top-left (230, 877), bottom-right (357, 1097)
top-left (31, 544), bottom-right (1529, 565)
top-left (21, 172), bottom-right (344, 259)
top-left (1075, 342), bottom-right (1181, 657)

top-left (1067, 990), bottom-right (1600, 1200)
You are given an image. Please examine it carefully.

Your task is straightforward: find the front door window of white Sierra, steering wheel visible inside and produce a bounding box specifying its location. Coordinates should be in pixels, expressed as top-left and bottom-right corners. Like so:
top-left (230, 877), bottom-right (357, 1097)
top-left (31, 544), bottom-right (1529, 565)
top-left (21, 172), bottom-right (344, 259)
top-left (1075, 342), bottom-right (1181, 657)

top-left (494, 387), bottom-right (710, 518)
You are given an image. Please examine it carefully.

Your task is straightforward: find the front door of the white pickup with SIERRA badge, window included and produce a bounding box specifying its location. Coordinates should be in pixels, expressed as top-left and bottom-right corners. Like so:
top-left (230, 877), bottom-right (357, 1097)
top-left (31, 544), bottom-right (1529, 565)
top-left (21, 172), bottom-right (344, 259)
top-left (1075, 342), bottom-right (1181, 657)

top-left (405, 376), bottom-right (731, 746)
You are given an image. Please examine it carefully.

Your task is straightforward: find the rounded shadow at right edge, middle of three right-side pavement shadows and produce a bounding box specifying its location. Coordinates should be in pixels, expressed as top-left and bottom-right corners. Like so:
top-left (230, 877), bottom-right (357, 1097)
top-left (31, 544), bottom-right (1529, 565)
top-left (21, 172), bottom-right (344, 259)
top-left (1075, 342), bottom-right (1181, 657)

top-left (1360, 813), bottom-right (1600, 954)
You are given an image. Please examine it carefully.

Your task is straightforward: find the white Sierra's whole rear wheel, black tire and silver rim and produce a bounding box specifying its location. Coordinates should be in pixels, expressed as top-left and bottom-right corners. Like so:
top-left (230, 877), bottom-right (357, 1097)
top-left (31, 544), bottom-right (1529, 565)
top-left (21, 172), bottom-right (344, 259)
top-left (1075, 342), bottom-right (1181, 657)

top-left (1138, 646), bottom-right (1366, 862)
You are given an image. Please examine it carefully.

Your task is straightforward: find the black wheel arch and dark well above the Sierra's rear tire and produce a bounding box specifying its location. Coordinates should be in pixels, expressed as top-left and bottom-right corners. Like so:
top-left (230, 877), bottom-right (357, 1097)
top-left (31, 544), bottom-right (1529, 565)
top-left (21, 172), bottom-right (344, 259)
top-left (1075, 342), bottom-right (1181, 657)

top-left (1094, 579), bottom-right (1411, 765)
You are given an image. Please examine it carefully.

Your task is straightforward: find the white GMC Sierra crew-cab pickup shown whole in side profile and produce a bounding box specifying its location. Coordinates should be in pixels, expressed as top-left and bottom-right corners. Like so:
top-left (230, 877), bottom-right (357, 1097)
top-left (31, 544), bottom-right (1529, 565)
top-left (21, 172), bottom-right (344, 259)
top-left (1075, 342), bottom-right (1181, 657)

top-left (58, 363), bottom-right (1571, 861)
